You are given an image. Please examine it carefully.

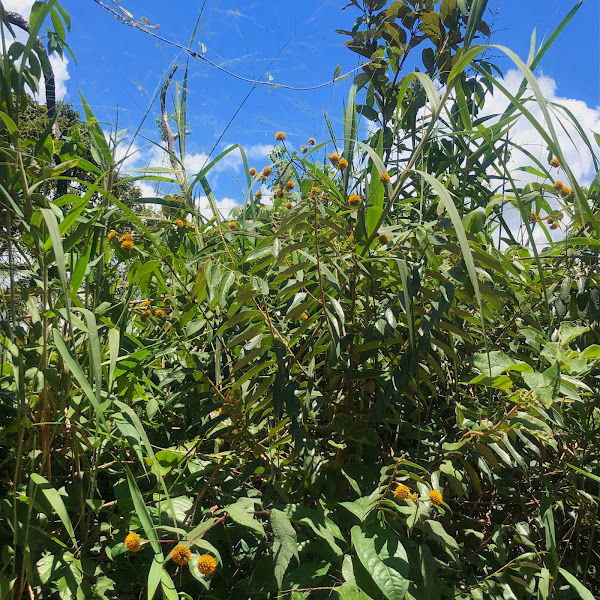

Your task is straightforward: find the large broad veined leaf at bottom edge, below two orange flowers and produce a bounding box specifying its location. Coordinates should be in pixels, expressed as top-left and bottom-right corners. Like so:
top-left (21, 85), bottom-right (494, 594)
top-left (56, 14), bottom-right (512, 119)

top-left (351, 525), bottom-right (410, 600)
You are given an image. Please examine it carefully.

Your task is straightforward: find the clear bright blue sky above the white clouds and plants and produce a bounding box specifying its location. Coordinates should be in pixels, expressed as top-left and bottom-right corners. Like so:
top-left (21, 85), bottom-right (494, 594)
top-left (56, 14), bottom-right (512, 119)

top-left (4, 0), bottom-right (600, 209)
